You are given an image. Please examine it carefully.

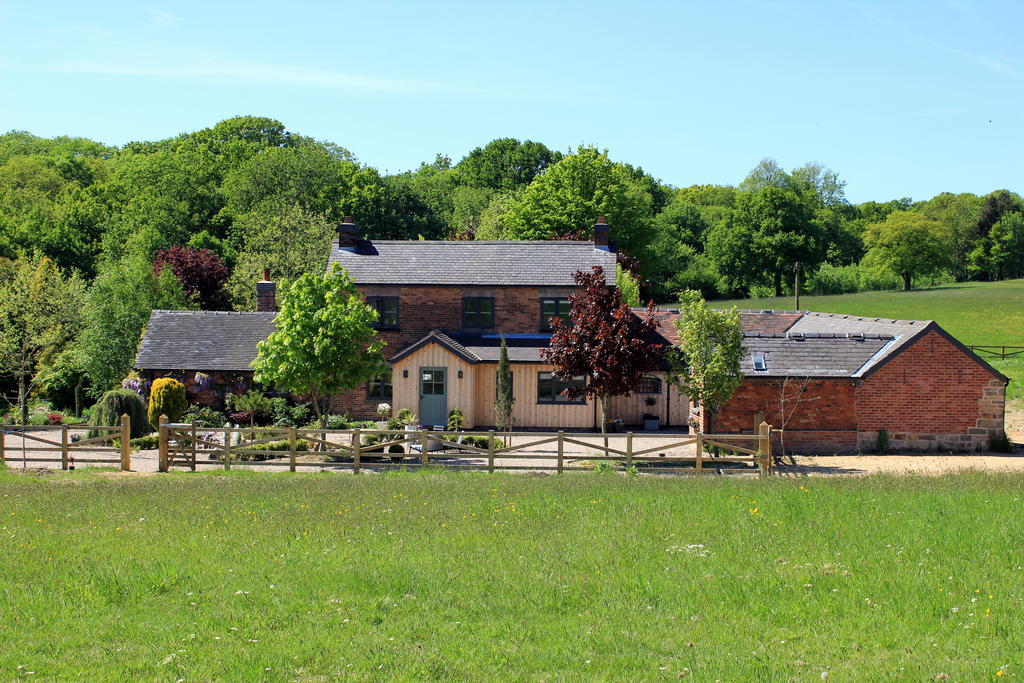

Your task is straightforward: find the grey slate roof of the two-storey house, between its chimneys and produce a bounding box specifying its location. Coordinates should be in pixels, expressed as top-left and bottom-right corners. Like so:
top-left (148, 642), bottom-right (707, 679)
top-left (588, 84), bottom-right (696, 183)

top-left (329, 241), bottom-right (615, 287)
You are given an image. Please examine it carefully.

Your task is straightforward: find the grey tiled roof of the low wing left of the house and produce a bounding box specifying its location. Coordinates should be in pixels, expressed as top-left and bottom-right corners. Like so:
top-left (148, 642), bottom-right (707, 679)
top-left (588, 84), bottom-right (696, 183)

top-left (135, 310), bottom-right (276, 372)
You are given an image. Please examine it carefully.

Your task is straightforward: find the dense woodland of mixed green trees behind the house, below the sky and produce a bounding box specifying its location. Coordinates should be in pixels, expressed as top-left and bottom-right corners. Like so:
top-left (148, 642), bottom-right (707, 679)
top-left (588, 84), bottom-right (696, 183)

top-left (0, 117), bottom-right (1024, 413)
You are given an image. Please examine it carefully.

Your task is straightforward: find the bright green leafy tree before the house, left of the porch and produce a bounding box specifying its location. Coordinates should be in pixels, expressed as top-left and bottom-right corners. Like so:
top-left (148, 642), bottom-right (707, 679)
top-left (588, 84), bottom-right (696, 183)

top-left (253, 264), bottom-right (387, 428)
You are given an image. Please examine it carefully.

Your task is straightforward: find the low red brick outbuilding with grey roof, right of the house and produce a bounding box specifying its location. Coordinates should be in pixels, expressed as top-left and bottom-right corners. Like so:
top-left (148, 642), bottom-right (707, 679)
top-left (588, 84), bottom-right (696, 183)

top-left (647, 310), bottom-right (1009, 453)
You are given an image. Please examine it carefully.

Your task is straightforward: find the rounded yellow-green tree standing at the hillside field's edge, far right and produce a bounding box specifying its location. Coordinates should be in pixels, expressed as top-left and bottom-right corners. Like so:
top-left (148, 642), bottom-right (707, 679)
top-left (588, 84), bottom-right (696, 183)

top-left (864, 211), bottom-right (953, 290)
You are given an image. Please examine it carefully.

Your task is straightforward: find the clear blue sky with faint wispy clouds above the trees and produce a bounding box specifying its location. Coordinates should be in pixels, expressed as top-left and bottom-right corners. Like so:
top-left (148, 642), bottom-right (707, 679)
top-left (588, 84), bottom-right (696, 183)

top-left (0, 0), bottom-right (1024, 202)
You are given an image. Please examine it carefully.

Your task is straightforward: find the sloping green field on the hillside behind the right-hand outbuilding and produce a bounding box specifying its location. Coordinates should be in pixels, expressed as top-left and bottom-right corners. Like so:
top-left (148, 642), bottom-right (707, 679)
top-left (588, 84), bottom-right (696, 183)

top-left (714, 280), bottom-right (1024, 399)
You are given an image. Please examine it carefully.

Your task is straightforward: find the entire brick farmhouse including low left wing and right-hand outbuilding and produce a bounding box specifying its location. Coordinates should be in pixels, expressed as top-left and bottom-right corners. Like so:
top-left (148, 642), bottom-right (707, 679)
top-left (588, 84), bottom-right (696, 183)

top-left (136, 221), bottom-right (1007, 453)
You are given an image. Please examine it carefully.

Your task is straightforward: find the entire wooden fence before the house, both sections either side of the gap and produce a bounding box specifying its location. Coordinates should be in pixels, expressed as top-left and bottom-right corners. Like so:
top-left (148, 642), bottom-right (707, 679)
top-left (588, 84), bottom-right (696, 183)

top-left (0, 415), bottom-right (772, 475)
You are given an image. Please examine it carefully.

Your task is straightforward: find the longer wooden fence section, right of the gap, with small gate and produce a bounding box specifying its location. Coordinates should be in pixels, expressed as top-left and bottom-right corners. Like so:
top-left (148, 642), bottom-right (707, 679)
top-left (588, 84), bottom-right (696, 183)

top-left (159, 416), bottom-right (772, 475)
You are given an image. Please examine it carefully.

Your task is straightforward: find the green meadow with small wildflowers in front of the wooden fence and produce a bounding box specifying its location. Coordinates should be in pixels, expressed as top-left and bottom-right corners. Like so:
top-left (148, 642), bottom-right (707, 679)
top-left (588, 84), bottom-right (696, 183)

top-left (0, 472), bottom-right (1024, 680)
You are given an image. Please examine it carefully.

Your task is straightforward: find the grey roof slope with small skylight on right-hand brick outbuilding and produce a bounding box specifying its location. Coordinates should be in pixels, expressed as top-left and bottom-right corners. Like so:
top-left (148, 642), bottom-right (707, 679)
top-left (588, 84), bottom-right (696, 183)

top-left (740, 333), bottom-right (894, 377)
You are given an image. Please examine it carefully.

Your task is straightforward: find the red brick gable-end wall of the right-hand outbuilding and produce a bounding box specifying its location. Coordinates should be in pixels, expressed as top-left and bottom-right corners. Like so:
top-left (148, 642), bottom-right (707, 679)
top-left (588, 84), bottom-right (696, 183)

top-left (857, 330), bottom-right (1006, 451)
